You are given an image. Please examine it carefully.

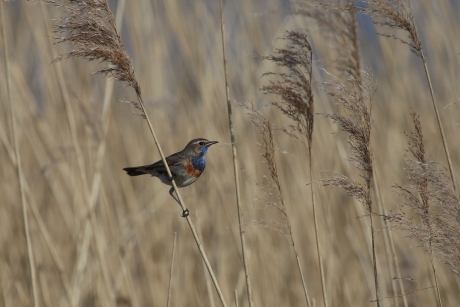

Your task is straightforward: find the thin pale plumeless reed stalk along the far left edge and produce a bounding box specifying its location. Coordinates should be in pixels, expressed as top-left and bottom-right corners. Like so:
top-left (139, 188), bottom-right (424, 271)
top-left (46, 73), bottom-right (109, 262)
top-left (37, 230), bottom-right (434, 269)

top-left (0, 1), bottom-right (39, 307)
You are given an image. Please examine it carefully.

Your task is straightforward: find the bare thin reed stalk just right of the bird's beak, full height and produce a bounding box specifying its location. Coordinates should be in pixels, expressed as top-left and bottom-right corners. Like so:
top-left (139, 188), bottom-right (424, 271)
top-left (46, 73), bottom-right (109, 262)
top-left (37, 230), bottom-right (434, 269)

top-left (220, 0), bottom-right (254, 307)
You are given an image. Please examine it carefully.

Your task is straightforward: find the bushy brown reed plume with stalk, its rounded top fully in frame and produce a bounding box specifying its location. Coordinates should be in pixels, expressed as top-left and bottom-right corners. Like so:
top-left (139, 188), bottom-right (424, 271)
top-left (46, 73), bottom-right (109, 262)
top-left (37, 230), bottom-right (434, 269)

top-left (262, 31), bottom-right (328, 307)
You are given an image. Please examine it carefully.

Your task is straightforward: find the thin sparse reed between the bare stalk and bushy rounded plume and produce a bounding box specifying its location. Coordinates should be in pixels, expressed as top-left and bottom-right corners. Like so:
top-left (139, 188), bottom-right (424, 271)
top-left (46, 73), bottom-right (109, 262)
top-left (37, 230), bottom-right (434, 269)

top-left (243, 104), bottom-right (311, 307)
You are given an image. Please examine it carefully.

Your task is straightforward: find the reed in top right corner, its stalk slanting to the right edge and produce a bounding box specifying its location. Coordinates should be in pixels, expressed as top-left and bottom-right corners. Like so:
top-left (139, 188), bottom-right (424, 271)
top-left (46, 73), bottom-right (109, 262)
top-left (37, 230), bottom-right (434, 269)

top-left (356, 0), bottom-right (457, 190)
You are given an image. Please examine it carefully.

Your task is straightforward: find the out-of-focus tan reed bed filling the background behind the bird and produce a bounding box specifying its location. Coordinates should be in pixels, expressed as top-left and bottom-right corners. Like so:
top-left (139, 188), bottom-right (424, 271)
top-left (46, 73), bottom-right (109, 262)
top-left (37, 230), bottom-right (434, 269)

top-left (0, 0), bottom-right (460, 306)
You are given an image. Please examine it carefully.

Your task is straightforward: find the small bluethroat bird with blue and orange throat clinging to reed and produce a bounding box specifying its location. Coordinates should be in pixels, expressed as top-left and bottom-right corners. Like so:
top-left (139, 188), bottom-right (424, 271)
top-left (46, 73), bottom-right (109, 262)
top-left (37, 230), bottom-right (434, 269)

top-left (123, 138), bottom-right (218, 217)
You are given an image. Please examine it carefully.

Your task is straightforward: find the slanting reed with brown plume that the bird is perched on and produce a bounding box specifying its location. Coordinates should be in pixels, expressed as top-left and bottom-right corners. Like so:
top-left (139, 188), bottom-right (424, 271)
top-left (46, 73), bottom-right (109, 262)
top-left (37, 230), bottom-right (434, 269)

top-left (42, 0), bottom-right (226, 307)
